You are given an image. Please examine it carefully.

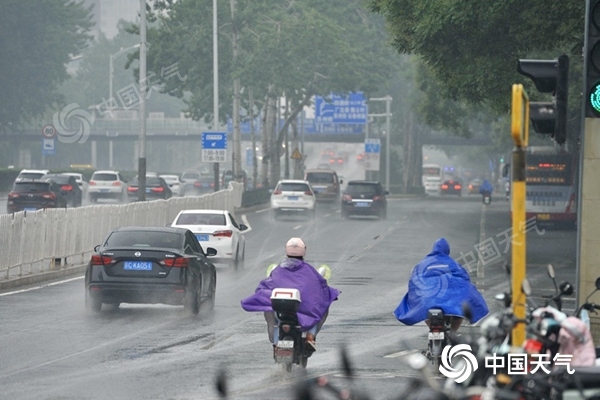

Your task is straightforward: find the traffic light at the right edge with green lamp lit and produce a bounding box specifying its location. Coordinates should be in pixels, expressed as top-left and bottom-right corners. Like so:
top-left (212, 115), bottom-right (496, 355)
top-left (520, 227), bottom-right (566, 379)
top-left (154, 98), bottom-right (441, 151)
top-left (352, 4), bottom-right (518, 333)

top-left (584, 0), bottom-right (600, 118)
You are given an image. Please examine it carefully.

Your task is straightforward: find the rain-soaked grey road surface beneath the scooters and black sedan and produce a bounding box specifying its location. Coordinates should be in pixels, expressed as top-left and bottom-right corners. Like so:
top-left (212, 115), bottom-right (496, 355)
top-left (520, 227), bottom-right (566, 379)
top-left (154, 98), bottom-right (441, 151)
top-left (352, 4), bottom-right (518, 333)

top-left (0, 196), bottom-right (575, 400)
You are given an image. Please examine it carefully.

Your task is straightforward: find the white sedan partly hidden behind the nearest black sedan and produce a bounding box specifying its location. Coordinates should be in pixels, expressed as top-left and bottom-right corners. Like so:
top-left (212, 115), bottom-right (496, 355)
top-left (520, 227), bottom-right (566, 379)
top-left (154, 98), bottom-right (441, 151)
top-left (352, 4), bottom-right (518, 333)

top-left (171, 210), bottom-right (248, 269)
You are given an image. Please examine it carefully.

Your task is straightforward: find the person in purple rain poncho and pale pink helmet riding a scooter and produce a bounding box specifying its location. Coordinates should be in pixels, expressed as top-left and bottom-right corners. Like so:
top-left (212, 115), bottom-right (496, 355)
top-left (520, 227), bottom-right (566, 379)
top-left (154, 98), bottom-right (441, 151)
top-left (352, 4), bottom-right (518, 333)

top-left (241, 238), bottom-right (340, 350)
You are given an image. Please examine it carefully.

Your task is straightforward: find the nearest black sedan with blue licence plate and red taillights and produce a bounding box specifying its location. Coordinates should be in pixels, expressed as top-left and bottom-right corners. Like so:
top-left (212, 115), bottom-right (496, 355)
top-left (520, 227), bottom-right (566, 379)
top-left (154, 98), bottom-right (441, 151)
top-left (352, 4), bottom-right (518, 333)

top-left (85, 227), bottom-right (217, 314)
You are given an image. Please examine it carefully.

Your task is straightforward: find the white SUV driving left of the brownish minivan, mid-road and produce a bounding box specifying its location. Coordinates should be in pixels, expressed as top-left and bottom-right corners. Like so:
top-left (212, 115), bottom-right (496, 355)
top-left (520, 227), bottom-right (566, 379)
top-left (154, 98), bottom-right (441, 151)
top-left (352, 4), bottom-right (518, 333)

top-left (271, 179), bottom-right (317, 219)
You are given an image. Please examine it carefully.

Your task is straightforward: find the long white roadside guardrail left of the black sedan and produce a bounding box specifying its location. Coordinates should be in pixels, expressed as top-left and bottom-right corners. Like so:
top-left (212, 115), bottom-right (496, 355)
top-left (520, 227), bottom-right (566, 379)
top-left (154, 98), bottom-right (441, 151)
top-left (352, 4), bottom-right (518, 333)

top-left (0, 182), bottom-right (243, 281)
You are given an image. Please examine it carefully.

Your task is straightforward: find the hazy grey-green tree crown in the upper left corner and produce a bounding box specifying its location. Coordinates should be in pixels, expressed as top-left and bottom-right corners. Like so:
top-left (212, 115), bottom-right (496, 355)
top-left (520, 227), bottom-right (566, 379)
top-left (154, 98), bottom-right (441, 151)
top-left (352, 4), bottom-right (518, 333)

top-left (0, 0), bottom-right (93, 132)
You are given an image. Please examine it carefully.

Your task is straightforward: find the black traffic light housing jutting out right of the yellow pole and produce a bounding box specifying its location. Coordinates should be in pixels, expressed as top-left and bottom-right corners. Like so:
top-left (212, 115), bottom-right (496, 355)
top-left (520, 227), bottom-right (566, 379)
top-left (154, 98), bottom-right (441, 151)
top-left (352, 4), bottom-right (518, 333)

top-left (517, 54), bottom-right (568, 144)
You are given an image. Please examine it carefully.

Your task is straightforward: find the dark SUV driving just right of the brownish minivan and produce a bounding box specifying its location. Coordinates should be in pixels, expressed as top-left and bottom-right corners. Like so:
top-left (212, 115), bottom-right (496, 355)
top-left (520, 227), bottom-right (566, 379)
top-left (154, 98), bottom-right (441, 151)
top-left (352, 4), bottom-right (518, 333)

top-left (341, 180), bottom-right (389, 219)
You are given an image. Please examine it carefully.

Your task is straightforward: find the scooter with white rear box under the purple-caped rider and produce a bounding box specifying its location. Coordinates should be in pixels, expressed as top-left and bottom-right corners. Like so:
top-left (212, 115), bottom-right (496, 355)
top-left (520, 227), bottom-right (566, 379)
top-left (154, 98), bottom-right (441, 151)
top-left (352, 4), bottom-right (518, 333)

top-left (271, 288), bottom-right (313, 372)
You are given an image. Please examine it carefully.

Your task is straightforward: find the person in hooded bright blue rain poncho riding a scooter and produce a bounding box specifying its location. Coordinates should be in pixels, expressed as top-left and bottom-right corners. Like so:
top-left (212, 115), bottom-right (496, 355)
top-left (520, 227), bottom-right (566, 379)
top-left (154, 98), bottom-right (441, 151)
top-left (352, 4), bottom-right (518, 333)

top-left (394, 238), bottom-right (489, 331)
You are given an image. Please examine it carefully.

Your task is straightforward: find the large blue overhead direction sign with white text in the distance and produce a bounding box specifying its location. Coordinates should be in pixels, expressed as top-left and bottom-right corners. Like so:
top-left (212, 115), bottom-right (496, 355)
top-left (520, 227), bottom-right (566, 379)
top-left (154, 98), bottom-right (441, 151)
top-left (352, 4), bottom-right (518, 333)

top-left (315, 92), bottom-right (368, 124)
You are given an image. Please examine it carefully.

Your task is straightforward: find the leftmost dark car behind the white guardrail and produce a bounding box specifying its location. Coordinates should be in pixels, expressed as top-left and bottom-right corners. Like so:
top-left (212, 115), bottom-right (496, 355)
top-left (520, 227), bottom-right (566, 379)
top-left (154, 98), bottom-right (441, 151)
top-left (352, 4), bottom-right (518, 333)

top-left (6, 180), bottom-right (67, 213)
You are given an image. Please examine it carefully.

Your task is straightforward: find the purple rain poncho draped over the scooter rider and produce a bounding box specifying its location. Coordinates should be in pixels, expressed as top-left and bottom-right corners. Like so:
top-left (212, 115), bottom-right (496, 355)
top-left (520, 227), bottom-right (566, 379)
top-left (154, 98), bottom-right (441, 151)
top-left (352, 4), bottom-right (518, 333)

top-left (242, 258), bottom-right (340, 331)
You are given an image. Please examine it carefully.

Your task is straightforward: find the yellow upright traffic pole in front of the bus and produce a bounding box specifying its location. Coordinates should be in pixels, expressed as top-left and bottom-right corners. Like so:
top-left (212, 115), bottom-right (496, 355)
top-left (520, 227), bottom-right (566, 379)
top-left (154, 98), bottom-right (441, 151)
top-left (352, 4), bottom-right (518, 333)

top-left (510, 84), bottom-right (529, 346)
